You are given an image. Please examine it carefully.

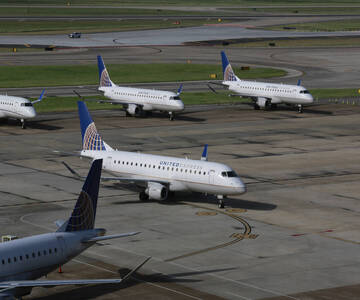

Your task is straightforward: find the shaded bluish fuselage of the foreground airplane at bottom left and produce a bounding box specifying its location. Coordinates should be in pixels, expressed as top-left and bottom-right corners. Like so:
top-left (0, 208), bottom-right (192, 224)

top-left (0, 229), bottom-right (101, 297)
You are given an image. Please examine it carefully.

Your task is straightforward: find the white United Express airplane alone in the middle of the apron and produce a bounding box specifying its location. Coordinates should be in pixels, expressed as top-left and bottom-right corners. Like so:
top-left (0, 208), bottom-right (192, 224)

top-left (67, 101), bottom-right (246, 208)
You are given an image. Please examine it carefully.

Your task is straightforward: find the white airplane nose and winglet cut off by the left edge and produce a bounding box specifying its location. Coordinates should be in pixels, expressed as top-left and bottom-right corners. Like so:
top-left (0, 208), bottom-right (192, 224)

top-left (0, 90), bottom-right (45, 129)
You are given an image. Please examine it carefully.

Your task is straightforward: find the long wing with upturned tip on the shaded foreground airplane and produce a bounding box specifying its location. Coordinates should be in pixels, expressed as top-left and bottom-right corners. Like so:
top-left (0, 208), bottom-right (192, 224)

top-left (0, 257), bottom-right (151, 293)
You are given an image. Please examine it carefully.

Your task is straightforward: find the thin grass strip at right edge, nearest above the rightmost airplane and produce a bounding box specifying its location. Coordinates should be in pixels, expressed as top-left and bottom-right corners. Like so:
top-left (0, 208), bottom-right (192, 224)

top-left (226, 37), bottom-right (360, 48)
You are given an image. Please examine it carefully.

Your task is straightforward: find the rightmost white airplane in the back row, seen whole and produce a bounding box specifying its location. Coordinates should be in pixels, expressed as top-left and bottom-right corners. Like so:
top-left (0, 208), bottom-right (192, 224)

top-left (209, 51), bottom-right (314, 113)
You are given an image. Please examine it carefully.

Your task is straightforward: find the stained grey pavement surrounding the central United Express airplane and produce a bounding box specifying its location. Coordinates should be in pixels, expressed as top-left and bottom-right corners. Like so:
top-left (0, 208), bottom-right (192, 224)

top-left (0, 104), bottom-right (360, 300)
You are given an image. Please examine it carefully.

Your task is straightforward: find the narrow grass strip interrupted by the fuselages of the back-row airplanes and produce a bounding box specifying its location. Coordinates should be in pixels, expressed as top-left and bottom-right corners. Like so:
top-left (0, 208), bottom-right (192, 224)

top-left (36, 89), bottom-right (359, 113)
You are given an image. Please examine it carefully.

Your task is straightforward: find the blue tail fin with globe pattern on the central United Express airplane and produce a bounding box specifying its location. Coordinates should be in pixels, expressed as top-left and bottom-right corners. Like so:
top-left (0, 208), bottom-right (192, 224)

top-left (78, 101), bottom-right (106, 151)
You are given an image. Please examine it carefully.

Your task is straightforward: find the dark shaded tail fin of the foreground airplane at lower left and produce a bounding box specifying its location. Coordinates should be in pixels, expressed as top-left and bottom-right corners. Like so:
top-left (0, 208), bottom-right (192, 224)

top-left (65, 159), bottom-right (102, 232)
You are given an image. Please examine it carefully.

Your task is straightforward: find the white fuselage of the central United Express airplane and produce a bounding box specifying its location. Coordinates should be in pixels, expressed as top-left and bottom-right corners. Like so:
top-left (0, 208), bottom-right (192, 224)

top-left (81, 150), bottom-right (246, 195)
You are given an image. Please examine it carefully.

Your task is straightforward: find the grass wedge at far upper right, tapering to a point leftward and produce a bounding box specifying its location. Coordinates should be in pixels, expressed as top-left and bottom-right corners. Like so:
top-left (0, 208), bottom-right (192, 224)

top-left (266, 19), bottom-right (360, 31)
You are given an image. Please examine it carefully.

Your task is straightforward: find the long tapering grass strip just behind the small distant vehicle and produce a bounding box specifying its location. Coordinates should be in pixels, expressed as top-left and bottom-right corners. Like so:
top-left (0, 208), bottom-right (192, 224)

top-left (0, 19), bottom-right (228, 34)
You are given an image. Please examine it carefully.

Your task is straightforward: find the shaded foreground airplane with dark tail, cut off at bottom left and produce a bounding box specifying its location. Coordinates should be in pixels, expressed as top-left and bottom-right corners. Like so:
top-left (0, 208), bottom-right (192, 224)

top-left (0, 160), bottom-right (150, 299)
